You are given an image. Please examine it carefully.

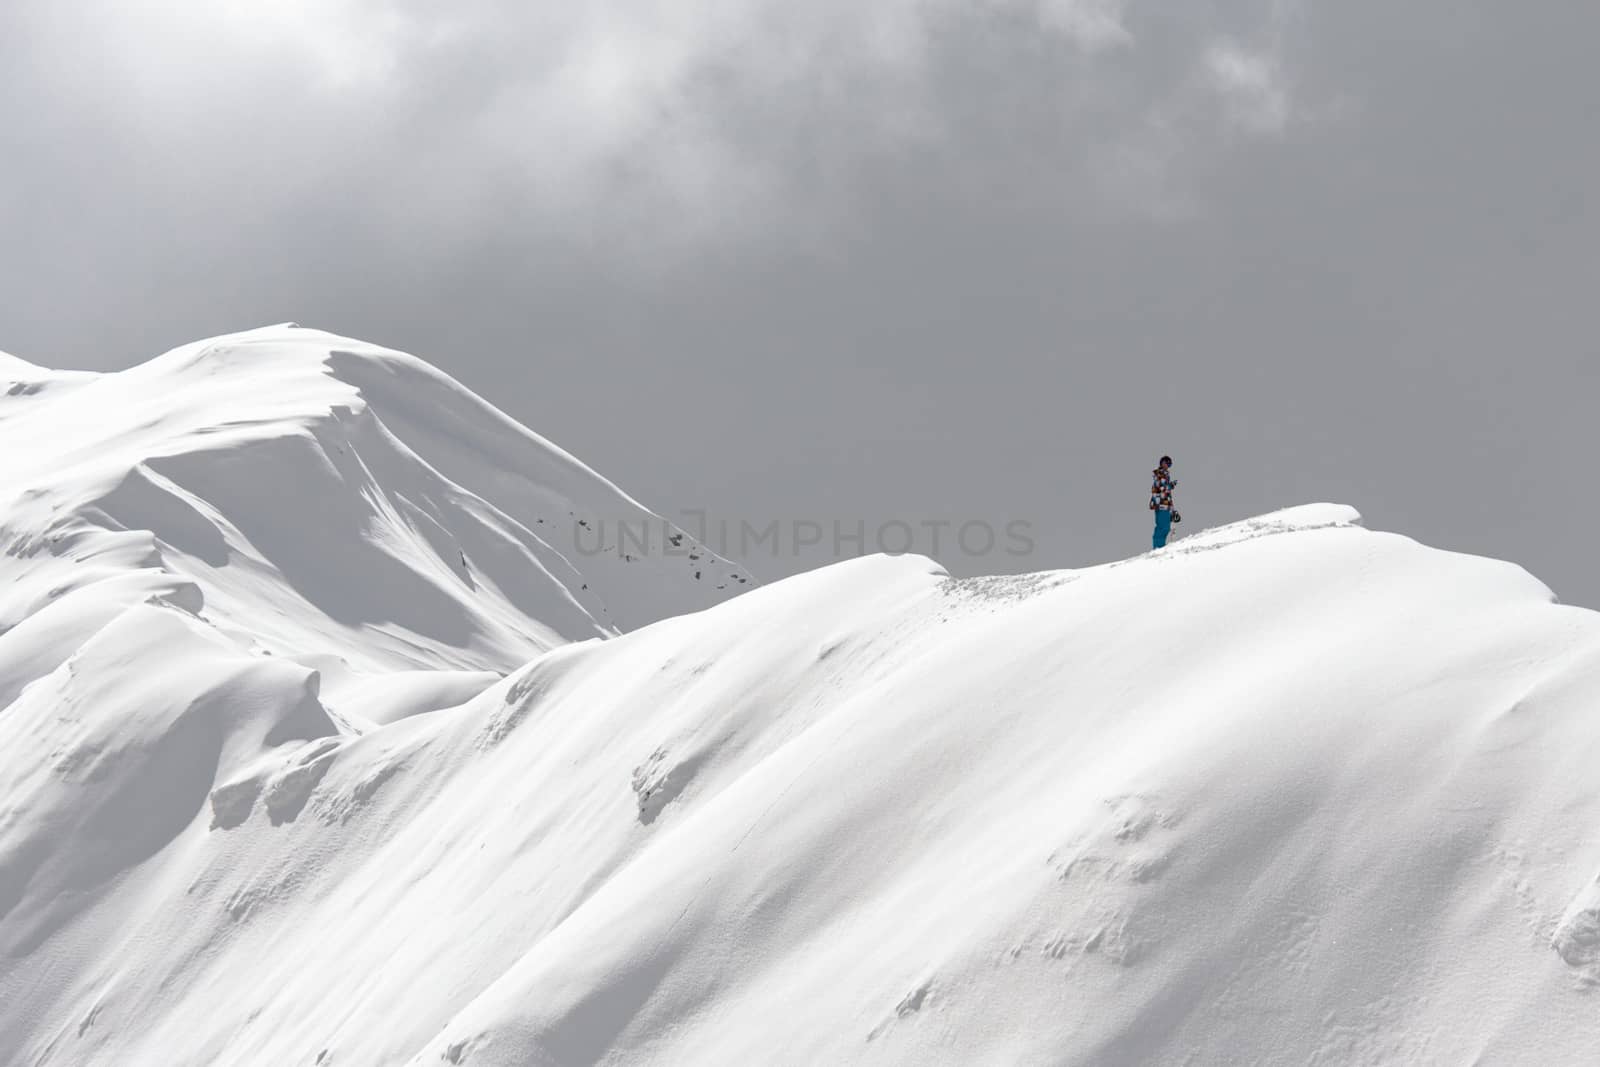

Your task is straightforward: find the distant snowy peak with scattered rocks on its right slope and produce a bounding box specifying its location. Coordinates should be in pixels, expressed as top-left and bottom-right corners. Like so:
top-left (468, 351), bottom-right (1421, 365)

top-left (0, 326), bottom-right (749, 696)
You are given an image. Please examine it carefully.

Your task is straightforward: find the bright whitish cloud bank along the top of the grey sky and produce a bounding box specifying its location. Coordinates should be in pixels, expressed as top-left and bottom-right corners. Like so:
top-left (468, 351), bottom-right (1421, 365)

top-left (0, 0), bottom-right (1294, 261)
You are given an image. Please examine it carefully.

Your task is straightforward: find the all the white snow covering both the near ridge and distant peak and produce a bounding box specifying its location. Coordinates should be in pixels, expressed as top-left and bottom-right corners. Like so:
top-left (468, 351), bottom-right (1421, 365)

top-left (0, 330), bottom-right (1600, 1067)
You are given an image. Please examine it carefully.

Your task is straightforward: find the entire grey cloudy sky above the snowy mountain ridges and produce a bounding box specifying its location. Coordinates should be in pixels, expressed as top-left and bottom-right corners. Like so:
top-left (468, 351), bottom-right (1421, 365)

top-left (0, 0), bottom-right (1600, 606)
